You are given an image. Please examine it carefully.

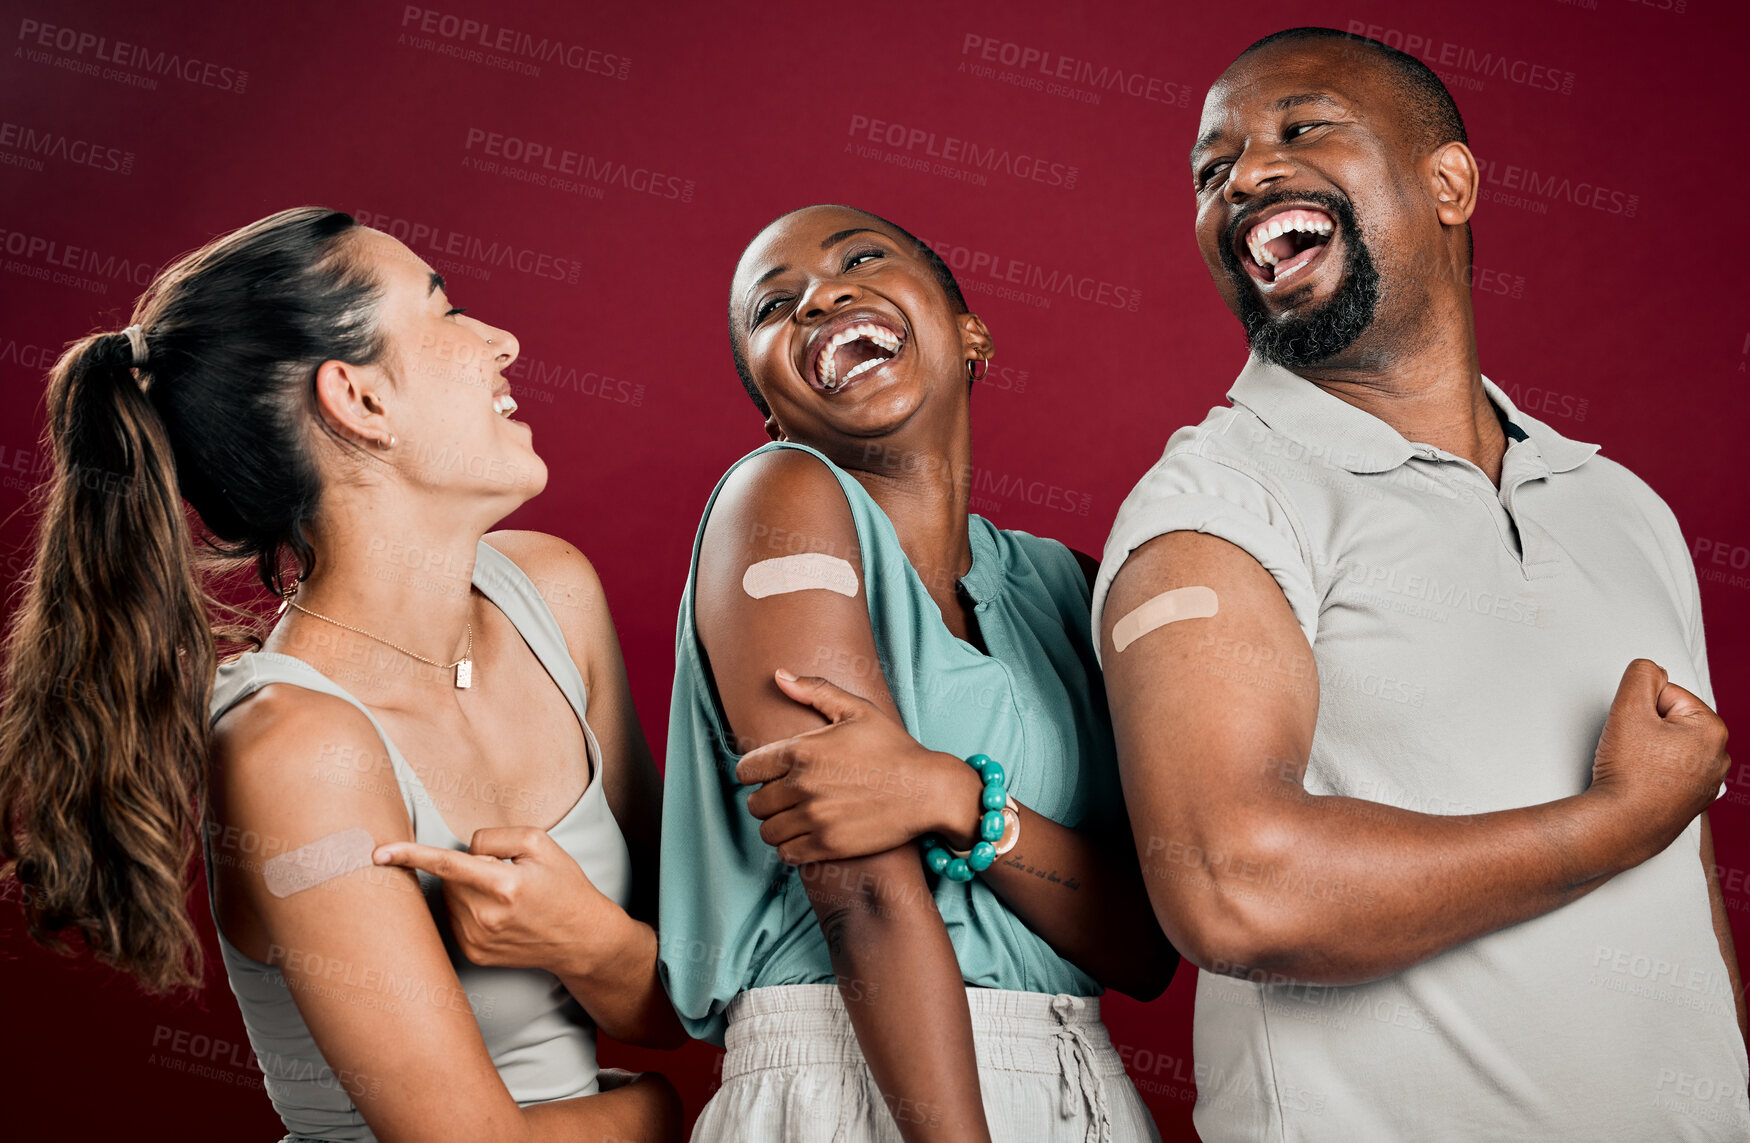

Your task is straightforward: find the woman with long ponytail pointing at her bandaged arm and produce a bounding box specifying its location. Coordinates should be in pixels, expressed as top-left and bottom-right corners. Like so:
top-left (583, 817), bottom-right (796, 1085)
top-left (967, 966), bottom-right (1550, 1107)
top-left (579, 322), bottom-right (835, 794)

top-left (0, 208), bottom-right (681, 1143)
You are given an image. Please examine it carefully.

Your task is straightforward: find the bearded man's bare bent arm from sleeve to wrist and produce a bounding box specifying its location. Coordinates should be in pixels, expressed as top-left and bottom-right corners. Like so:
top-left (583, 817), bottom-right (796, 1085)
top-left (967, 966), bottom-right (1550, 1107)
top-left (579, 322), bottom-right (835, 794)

top-left (1101, 532), bottom-right (1673, 984)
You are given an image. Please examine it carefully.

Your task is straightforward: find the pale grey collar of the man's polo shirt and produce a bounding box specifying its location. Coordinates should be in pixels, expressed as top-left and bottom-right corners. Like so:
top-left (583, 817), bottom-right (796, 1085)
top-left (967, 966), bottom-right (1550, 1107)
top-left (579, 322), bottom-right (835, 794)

top-left (1227, 357), bottom-right (1598, 473)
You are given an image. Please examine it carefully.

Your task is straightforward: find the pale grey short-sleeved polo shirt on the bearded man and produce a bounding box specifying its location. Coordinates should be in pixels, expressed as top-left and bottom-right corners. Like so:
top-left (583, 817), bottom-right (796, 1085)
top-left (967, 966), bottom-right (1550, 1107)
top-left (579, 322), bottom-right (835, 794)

top-left (1094, 359), bottom-right (1750, 1143)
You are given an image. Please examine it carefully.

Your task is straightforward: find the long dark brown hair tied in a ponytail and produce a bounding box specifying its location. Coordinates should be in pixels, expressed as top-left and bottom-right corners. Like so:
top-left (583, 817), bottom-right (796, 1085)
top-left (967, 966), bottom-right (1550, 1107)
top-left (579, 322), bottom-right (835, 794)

top-left (0, 207), bottom-right (383, 992)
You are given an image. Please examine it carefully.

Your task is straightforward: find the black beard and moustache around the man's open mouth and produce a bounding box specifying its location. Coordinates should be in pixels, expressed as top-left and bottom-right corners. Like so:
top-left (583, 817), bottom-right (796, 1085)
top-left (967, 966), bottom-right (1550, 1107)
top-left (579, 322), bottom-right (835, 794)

top-left (1222, 191), bottom-right (1379, 369)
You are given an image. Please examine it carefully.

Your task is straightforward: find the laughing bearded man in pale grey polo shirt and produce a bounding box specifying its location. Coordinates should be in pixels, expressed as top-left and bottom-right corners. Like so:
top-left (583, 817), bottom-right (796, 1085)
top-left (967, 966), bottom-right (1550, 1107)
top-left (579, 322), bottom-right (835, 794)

top-left (1094, 28), bottom-right (1750, 1143)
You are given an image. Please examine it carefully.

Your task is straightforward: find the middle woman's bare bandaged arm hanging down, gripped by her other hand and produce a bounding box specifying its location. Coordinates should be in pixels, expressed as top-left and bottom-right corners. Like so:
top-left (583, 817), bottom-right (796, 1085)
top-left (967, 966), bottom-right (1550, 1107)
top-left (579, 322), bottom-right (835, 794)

top-left (695, 452), bottom-right (989, 1143)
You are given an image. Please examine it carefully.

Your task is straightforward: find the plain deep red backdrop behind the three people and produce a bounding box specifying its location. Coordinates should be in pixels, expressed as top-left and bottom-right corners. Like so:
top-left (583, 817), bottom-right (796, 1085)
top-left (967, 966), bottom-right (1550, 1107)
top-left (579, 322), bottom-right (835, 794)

top-left (0, 0), bottom-right (1750, 1141)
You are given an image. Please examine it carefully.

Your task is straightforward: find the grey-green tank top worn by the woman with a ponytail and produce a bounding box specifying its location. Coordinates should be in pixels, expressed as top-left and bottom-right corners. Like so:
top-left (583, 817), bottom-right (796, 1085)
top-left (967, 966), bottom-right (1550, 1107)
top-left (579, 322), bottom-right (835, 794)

top-left (201, 541), bottom-right (632, 1143)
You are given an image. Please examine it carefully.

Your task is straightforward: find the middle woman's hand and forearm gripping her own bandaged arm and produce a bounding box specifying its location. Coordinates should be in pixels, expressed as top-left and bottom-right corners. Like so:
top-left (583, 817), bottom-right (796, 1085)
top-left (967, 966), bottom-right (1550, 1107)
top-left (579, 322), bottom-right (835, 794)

top-left (735, 672), bottom-right (1180, 999)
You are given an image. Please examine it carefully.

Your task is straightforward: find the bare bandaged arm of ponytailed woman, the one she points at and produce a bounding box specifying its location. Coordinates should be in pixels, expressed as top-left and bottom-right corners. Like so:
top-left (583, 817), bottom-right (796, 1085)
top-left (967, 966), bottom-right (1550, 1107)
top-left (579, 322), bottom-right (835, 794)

top-left (214, 686), bottom-right (681, 1143)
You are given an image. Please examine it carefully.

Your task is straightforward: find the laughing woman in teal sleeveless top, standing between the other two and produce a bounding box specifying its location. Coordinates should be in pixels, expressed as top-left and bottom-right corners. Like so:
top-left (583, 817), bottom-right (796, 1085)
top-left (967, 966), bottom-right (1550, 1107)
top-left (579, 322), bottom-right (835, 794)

top-left (662, 207), bottom-right (1178, 1143)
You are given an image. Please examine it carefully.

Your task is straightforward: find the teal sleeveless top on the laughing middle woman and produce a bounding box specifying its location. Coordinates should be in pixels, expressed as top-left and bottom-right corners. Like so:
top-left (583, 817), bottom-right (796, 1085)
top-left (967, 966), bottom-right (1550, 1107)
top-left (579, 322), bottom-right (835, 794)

top-left (658, 443), bottom-right (1124, 1045)
